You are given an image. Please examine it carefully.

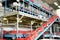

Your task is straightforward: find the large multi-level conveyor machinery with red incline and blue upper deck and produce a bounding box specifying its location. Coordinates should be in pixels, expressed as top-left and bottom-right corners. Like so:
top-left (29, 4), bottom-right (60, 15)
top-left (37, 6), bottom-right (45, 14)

top-left (2, 0), bottom-right (58, 40)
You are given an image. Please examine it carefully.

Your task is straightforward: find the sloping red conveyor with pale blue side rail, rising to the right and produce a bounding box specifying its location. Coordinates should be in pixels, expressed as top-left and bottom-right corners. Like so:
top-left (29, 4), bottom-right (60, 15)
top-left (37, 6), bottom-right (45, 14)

top-left (16, 15), bottom-right (58, 40)
